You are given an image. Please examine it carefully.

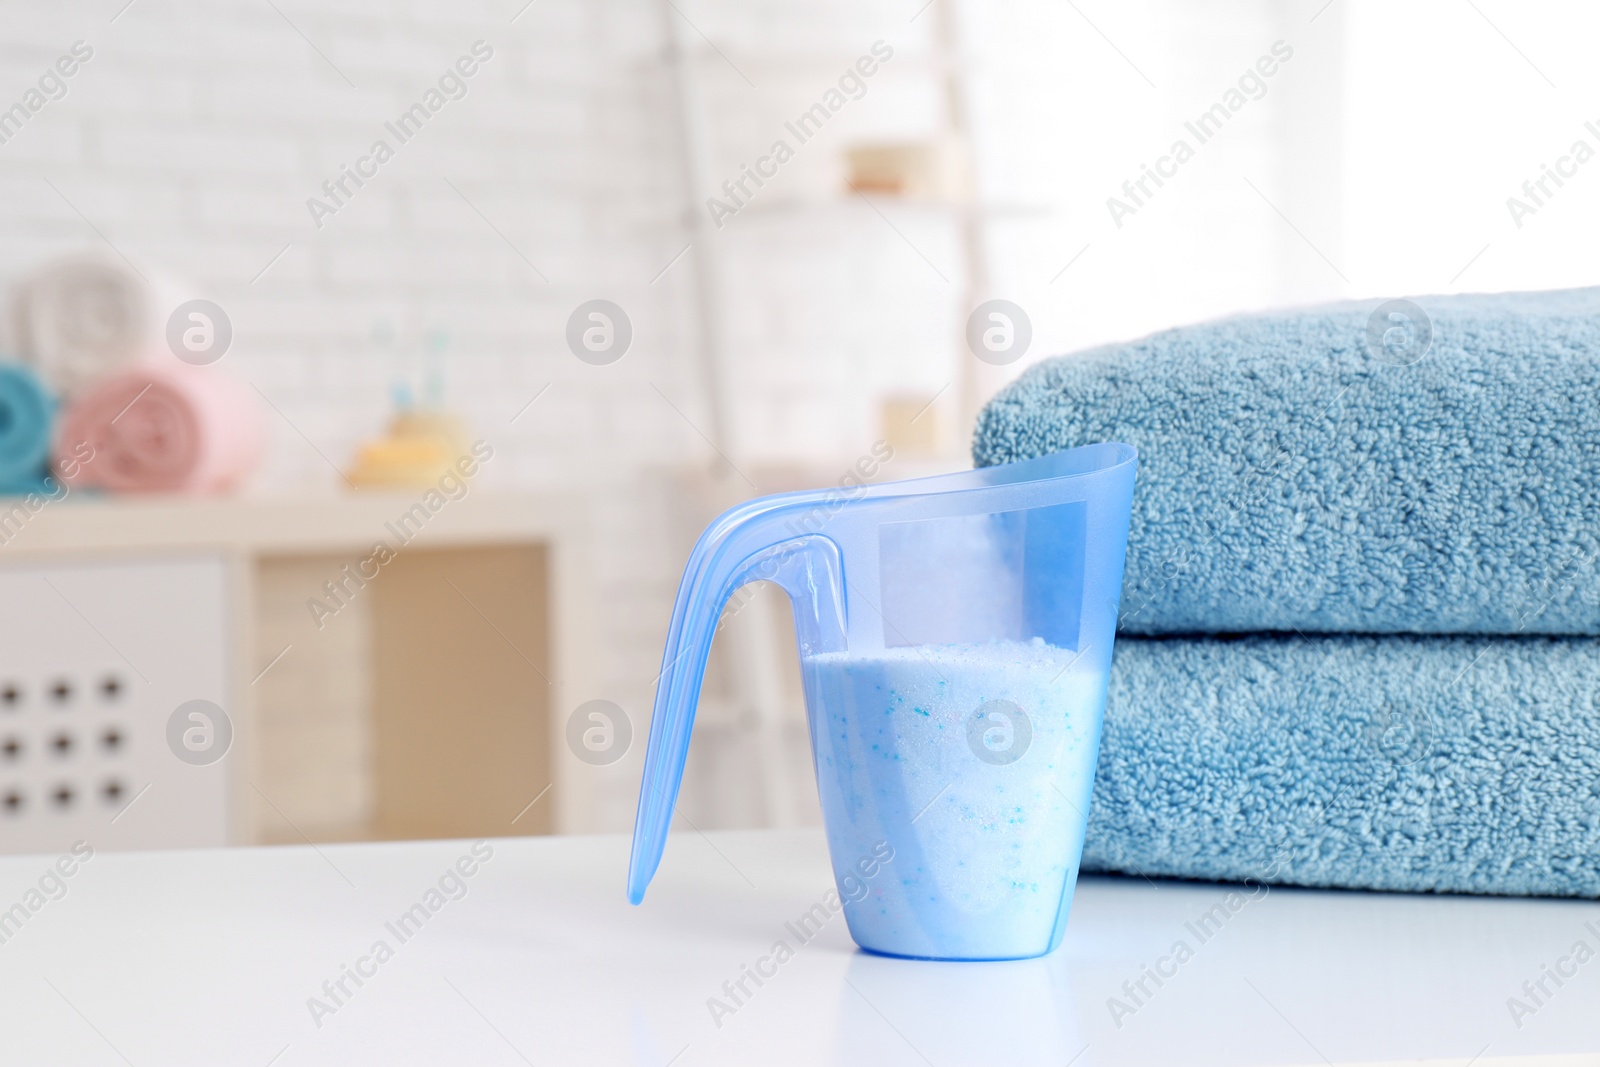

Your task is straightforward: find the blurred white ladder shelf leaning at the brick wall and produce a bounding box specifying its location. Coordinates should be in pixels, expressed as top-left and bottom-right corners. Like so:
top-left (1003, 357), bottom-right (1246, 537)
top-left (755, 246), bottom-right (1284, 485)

top-left (646, 0), bottom-right (998, 827)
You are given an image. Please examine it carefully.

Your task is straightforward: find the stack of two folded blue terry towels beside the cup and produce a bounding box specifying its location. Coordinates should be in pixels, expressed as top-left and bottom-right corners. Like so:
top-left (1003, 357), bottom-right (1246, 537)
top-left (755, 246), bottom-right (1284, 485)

top-left (973, 290), bottom-right (1600, 897)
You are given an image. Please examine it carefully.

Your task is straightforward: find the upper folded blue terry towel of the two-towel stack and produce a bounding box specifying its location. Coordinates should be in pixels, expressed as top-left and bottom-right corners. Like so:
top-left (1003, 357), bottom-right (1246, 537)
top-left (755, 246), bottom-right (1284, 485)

top-left (973, 290), bottom-right (1600, 635)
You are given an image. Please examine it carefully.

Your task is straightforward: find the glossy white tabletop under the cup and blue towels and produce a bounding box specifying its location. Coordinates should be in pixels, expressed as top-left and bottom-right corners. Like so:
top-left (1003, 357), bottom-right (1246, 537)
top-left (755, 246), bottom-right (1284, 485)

top-left (0, 830), bottom-right (1600, 1067)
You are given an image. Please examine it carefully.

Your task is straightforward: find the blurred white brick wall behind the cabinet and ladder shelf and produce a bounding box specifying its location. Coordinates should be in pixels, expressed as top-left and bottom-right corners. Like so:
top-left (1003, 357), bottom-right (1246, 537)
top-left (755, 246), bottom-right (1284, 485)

top-left (0, 0), bottom-right (1336, 827)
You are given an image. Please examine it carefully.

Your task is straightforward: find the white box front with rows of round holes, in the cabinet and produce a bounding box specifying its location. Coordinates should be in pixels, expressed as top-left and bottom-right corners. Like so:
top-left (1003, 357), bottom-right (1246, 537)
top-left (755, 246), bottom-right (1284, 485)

top-left (0, 557), bottom-right (238, 853)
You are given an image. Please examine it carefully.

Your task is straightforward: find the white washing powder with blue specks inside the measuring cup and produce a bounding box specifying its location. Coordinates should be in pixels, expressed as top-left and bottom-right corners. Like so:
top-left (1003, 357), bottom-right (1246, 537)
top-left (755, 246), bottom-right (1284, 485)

top-left (803, 638), bottom-right (1107, 958)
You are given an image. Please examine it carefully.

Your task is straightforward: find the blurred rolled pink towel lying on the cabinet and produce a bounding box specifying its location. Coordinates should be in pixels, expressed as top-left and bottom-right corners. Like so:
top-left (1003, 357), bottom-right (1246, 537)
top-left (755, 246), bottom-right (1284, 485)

top-left (56, 362), bottom-right (264, 494)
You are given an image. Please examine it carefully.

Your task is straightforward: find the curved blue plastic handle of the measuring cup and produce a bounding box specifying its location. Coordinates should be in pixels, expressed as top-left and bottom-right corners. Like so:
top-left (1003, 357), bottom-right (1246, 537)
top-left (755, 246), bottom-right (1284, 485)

top-left (627, 498), bottom-right (845, 904)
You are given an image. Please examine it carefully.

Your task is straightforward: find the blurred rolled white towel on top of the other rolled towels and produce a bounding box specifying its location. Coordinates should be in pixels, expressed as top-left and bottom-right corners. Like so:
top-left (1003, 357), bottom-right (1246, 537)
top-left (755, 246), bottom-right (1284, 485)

top-left (11, 253), bottom-right (187, 397)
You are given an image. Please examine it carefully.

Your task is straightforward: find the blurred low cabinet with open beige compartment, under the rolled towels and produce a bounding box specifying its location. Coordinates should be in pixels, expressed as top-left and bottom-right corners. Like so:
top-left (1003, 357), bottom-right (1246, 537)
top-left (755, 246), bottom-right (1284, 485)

top-left (0, 491), bottom-right (598, 851)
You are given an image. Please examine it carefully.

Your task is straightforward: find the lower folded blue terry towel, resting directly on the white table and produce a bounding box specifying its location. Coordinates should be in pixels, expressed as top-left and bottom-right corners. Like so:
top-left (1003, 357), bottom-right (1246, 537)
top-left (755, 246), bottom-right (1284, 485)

top-left (1083, 637), bottom-right (1600, 897)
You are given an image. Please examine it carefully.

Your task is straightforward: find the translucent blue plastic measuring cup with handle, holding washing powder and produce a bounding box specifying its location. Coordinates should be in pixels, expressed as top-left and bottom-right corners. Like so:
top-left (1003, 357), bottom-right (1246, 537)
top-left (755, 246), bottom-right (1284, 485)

top-left (627, 443), bottom-right (1138, 960)
